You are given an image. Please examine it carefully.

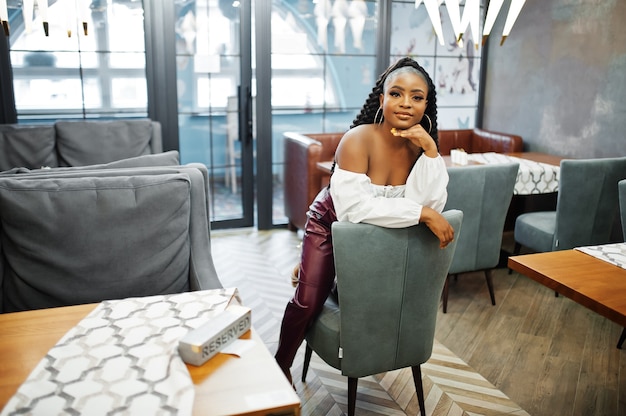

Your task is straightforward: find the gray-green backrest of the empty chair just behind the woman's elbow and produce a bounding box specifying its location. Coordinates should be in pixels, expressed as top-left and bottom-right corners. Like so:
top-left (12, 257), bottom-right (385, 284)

top-left (444, 163), bottom-right (519, 274)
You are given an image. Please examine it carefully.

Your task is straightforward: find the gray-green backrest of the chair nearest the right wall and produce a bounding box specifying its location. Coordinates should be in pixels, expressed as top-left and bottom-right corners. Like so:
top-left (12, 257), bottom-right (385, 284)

top-left (552, 157), bottom-right (626, 250)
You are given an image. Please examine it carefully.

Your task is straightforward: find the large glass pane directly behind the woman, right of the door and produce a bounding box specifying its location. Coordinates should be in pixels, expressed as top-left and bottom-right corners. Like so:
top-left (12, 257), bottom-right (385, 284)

top-left (257, 0), bottom-right (381, 228)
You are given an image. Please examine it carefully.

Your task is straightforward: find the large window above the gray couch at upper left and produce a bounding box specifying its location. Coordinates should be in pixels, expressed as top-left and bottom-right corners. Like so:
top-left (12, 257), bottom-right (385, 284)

top-left (9, 0), bottom-right (148, 122)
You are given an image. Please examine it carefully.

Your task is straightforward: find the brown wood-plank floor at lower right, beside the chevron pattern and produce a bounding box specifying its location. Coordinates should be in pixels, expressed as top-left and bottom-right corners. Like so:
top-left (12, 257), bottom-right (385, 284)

top-left (436, 232), bottom-right (626, 416)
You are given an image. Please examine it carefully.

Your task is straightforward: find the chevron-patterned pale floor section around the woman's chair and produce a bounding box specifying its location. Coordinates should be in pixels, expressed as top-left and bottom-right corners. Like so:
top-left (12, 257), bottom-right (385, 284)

top-left (211, 230), bottom-right (528, 416)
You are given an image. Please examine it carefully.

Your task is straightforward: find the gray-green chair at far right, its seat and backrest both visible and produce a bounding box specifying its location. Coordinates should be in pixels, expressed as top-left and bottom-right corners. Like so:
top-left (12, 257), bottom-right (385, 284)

top-left (513, 157), bottom-right (626, 254)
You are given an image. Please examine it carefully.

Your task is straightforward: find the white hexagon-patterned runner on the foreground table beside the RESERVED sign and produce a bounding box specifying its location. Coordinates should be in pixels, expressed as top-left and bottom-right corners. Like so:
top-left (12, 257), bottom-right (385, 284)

top-left (1, 288), bottom-right (240, 416)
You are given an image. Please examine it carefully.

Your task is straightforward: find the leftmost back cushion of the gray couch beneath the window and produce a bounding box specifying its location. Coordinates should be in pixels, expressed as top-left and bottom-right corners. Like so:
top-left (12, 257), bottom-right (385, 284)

top-left (0, 125), bottom-right (58, 171)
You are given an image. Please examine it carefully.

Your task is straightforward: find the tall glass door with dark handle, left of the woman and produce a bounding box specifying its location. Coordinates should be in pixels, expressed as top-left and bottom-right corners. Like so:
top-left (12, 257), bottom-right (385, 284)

top-left (176, 0), bottom-right (254, 229)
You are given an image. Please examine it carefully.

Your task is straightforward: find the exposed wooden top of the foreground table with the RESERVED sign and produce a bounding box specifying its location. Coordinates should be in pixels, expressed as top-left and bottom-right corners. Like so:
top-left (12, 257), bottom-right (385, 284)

top-left (0, 304), bottom-right (300, 415)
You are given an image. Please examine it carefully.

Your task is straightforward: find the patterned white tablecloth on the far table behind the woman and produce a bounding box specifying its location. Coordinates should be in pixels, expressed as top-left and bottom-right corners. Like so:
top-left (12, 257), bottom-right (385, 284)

top-left (468, 152), bottom-right (560, 195)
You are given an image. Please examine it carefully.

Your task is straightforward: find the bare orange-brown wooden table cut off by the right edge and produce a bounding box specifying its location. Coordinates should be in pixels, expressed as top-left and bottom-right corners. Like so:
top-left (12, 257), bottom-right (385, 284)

top-left (508, 250), bottom-right (626, 348)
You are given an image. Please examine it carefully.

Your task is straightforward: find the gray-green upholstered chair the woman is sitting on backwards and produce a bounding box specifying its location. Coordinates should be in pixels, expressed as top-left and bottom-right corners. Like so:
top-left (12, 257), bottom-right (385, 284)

top-left (302, 210), bottom-right (463, 416)
